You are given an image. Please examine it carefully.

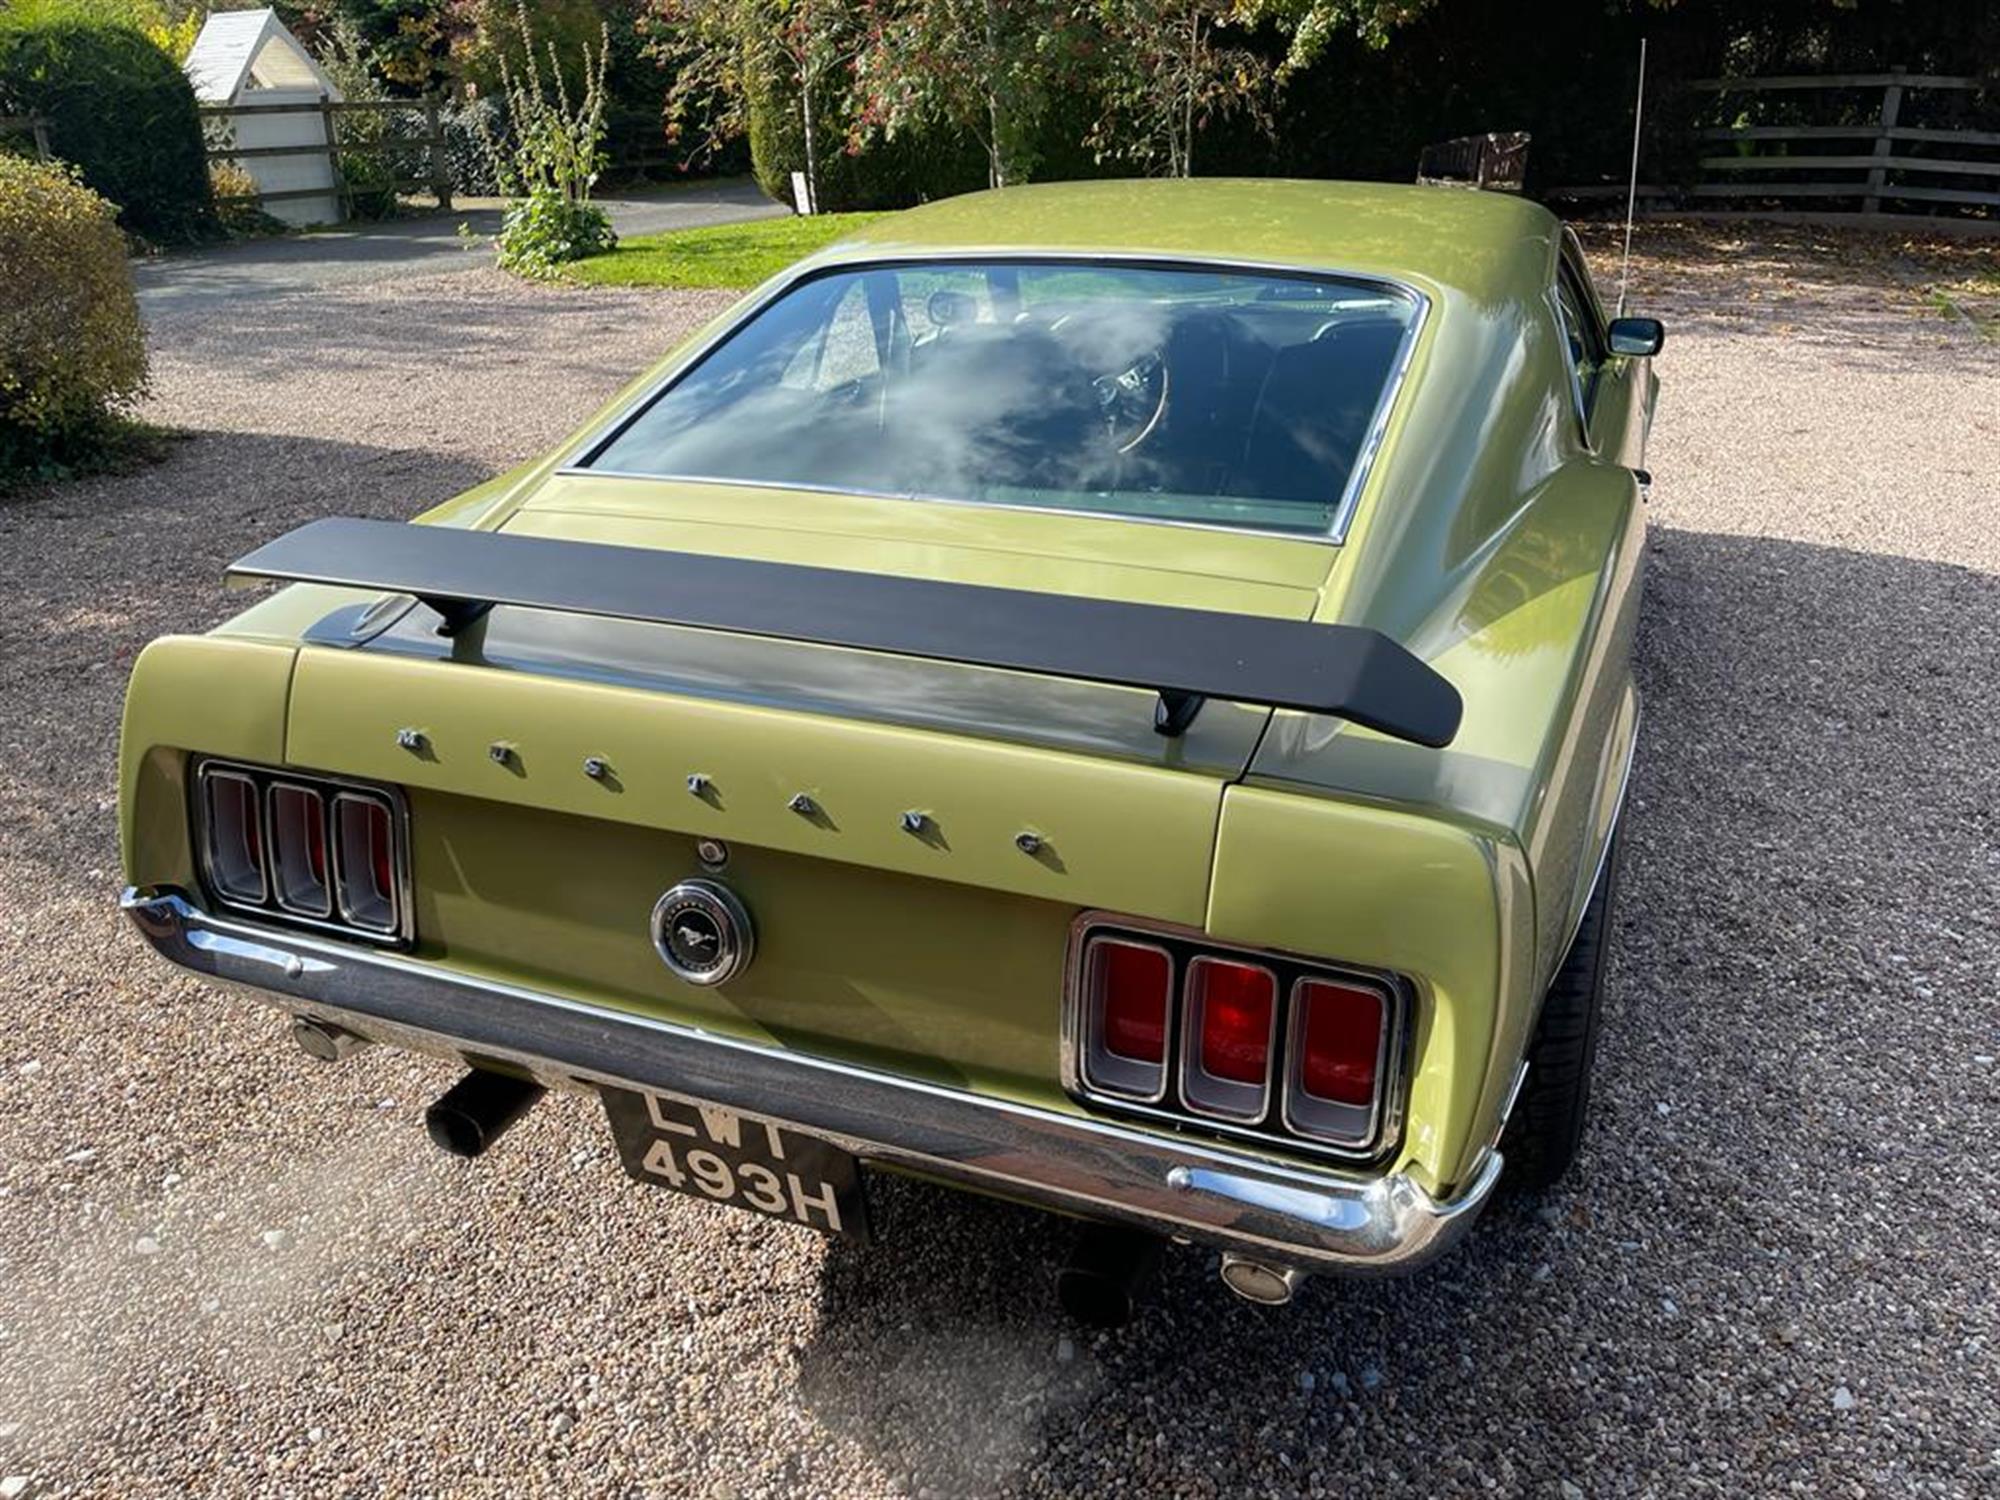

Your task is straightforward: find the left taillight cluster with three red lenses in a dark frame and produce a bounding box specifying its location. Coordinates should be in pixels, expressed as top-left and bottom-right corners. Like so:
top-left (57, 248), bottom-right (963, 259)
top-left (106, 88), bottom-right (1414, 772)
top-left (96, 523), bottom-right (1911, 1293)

top-left (194, 760), bottom-right (410, 942)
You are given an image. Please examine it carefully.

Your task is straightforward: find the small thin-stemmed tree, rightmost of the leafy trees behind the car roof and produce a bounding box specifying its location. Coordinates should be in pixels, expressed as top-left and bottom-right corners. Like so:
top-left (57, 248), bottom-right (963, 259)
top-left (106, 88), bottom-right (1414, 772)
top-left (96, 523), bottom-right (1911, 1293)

top-left (1090, 0), bottom-right (1272, 178)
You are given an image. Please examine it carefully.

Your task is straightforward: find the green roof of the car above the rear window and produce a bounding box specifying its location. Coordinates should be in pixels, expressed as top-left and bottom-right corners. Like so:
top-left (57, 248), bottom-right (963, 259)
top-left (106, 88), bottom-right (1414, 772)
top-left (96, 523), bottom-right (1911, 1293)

top-left (814, 178), bottom-right (1562, 302)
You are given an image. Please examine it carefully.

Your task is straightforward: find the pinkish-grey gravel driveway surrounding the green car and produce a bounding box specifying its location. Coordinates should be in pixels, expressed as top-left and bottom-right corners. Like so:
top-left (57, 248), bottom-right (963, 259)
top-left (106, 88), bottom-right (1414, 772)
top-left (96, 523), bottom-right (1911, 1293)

top-left (0, 226), bottom-right (2000, 1500)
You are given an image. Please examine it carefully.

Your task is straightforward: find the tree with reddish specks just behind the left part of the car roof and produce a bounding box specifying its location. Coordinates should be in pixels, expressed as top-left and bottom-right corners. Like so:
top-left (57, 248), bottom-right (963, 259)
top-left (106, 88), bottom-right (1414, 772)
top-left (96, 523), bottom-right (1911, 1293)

top-left (852, 0), bottom-right (1092, 188)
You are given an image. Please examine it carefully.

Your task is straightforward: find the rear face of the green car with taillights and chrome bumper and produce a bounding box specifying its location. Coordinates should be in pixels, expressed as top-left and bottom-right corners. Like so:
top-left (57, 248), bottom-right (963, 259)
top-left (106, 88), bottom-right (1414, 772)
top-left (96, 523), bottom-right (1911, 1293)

top-left (124, 592), bottom-right (1510, 1296)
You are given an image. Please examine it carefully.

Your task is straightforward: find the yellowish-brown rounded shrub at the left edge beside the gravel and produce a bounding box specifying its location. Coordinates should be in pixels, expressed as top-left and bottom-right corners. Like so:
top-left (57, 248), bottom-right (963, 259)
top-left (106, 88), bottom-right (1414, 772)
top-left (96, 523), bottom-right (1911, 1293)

top-left (0, 156), bottom-right (146, 484)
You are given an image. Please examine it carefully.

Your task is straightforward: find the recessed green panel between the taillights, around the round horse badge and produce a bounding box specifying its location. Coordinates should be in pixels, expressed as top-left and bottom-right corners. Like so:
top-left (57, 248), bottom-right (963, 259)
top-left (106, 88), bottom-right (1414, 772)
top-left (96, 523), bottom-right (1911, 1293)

top-left (394, 792), bottom-right (1070, 1104)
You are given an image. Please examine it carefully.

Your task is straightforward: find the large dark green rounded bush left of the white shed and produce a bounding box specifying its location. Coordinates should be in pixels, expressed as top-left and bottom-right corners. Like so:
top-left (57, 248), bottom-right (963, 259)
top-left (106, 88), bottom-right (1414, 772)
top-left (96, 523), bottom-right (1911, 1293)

top-left (0, 10), bottom-right (216, 244)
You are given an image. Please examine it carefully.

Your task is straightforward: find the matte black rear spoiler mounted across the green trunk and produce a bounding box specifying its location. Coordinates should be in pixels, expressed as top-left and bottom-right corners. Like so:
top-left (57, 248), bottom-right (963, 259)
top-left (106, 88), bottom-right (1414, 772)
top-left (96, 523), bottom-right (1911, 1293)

top-left (228, 520), bottom-right (1462, 746)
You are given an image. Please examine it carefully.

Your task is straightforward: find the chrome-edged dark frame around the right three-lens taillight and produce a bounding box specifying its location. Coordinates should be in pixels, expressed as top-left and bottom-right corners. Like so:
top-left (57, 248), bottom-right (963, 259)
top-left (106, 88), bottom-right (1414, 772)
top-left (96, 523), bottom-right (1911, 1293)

top-left (1058, 910), bottom-right (1418, 1164)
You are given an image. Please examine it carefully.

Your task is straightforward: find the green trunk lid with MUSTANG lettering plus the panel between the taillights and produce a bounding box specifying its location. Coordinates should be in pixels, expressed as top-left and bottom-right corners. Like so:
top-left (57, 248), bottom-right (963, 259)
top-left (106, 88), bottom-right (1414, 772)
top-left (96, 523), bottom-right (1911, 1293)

top-left (286, 476), bottom-right (1332, 1094)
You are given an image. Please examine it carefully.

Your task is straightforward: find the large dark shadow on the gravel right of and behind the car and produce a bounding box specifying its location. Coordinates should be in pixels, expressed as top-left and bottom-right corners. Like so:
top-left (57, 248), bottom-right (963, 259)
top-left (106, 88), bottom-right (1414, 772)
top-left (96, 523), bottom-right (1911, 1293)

top-left (800, 530), bottom-right (2000, 1494)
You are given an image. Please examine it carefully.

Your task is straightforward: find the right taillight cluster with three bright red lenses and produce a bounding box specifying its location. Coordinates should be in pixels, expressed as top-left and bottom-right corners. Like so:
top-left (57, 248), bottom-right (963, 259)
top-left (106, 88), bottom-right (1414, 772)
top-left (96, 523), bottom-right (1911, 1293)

top-left (1068, 920), bottom-right (1404, 1156)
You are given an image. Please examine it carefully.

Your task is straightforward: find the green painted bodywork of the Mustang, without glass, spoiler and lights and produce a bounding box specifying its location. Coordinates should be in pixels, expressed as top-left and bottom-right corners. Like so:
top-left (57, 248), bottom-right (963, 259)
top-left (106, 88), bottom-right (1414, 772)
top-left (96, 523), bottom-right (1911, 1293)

top-left (120, 180), bottom-right (1656, 1224)
